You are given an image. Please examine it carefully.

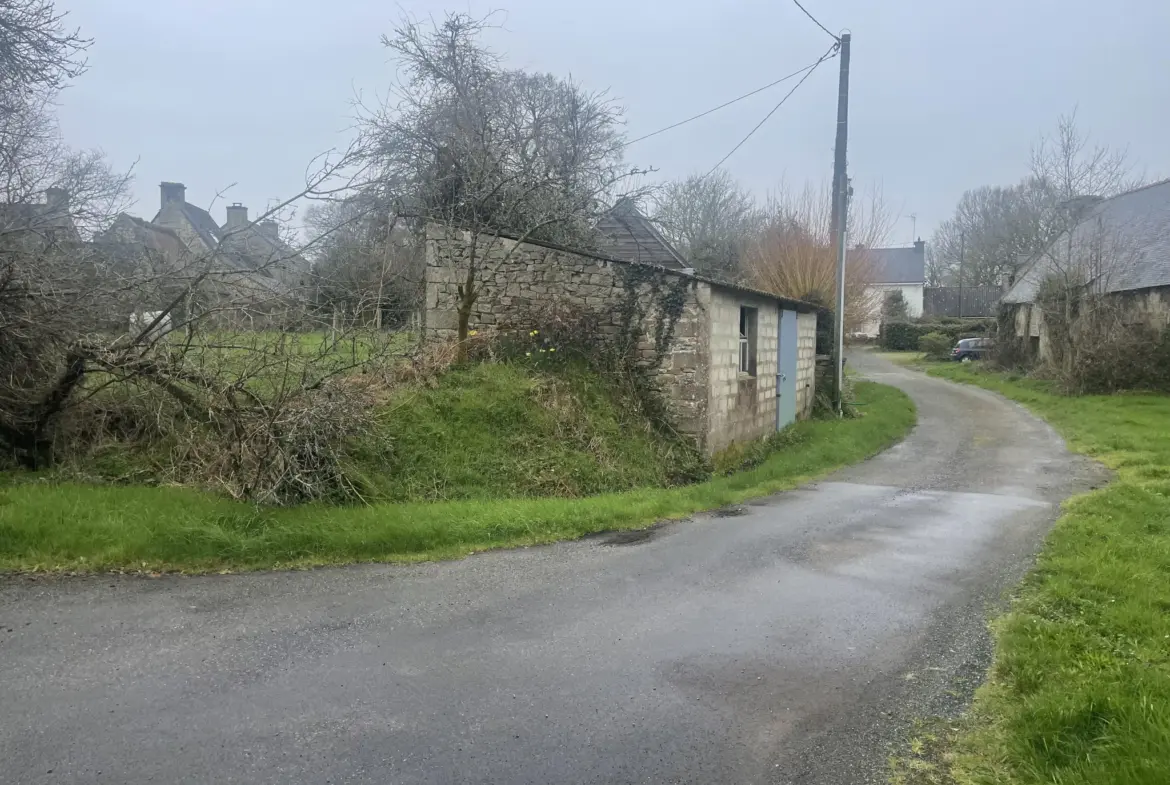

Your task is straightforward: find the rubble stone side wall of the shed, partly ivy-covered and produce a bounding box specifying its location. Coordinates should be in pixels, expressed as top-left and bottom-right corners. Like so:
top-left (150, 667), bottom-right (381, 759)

top-left (424, 226), bottom-right (711, 442)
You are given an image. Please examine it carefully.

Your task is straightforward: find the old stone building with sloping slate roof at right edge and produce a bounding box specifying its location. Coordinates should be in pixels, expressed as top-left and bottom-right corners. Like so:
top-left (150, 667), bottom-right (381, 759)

top-left (998, 180), bottom-right (1170, 361)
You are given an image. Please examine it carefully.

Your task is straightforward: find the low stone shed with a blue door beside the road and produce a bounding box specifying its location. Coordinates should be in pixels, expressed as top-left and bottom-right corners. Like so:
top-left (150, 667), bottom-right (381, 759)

top-left (424, 215), bottom-right (817, 455)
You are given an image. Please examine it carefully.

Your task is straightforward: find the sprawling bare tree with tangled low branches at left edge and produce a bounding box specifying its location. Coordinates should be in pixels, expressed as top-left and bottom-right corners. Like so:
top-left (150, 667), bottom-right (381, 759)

top-left (0, 0), bottom-right (416, 502)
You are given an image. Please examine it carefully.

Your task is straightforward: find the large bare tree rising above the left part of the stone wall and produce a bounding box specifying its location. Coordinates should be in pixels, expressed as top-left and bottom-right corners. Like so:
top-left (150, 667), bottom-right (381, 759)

top-left (362, 14), bottom-right (638, 339)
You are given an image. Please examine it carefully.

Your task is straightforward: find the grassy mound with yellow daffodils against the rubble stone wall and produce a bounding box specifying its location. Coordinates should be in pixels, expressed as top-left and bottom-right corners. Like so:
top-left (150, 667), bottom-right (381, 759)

top-left (345, 363), bottom-right (703, 502)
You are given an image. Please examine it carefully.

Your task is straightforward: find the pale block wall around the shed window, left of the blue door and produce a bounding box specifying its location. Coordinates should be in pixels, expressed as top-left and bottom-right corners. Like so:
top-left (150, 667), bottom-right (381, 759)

top-left (707, 287), bottom-right (779, 453)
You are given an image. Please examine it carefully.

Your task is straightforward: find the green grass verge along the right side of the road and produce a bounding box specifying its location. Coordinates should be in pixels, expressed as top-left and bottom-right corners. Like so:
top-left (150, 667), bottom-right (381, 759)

top-left (908, 364), bottom-right (1170, 785)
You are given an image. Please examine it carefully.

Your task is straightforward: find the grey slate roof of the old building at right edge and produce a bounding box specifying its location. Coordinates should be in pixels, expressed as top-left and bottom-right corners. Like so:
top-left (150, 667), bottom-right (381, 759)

top-left (1003, 180), bottom-right (1170, 303)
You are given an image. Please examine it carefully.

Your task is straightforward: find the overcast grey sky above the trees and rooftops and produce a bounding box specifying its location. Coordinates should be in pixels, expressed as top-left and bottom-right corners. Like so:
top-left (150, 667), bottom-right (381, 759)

top-left (59, 0), bottom-right (1170, 242)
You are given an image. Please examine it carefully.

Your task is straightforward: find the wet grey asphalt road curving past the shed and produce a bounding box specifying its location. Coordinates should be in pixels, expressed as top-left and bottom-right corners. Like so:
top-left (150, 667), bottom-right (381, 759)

top-left (0, 356), bottom-right (1095, 785)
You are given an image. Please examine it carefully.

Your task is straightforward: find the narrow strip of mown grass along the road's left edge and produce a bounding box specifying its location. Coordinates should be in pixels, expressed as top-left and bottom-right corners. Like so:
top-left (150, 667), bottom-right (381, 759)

top-left (0, 383), bottom-right (915, 571)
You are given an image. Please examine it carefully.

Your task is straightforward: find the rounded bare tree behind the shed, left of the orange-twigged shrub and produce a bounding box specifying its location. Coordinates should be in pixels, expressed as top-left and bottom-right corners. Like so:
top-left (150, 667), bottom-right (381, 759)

top-left (653, 170), bottom-right (764, 278)
